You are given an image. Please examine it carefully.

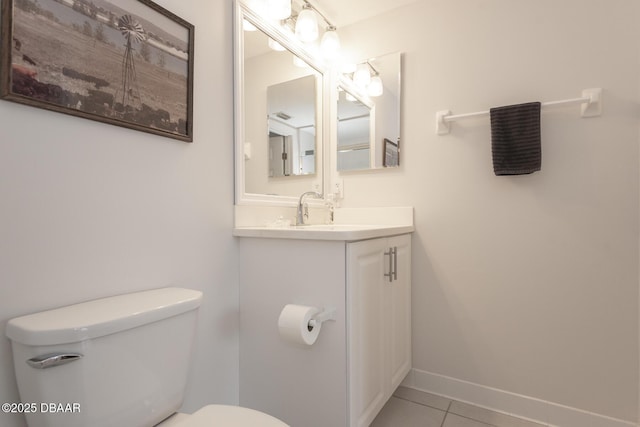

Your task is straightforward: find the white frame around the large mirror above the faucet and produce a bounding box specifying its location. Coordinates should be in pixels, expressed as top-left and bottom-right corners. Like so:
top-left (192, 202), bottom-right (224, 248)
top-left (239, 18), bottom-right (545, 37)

top-left (233, 0), bottom-right (332, 206)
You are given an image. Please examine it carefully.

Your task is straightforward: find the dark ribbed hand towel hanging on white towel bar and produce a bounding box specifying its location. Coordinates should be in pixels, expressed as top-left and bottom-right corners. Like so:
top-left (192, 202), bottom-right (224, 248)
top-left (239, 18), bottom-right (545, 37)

top-left (490, 102), bottom-right (542, 175)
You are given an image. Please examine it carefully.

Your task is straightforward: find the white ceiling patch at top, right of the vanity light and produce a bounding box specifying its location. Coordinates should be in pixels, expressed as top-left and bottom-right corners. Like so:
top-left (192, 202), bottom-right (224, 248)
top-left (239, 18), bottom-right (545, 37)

top-left (308, 0), bottom-right (421, 28)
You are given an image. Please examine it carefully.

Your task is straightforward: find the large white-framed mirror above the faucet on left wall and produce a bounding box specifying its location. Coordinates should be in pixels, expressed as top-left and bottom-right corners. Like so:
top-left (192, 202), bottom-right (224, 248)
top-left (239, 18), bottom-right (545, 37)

top-left (235, 2), bottom-right (323, 201)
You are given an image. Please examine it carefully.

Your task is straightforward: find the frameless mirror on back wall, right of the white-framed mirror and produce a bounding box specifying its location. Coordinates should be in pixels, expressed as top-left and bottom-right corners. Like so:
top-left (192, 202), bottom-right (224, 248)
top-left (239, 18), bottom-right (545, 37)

top-left (336, 52), bottom-right (402, 172)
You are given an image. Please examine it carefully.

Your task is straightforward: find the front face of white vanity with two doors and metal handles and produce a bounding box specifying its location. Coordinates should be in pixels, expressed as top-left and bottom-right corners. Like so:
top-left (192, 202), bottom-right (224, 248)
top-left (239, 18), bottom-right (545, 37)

top-left (347, 234), bottom-right (411, 427)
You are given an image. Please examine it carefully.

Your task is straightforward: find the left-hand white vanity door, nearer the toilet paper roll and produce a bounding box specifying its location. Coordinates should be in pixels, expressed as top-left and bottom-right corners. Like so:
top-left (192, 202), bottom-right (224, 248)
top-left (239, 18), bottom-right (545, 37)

top-left (347, 239), bottom-right (388, 427)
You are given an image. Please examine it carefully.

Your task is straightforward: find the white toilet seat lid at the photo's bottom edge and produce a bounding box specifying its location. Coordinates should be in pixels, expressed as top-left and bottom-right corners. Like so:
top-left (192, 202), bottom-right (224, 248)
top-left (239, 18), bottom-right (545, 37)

top-left (171, 405), bottom-right (289, 427)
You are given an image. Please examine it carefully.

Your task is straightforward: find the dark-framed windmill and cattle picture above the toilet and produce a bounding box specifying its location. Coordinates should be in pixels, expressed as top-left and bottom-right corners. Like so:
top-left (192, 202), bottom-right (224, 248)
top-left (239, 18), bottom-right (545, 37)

top-left (0, 0), bottom-right (194, 142)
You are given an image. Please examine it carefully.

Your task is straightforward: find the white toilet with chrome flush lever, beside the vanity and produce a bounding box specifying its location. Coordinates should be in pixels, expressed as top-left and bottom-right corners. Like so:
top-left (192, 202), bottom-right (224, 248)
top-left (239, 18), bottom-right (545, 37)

top-left (6, 288), bottom-right (288, 427)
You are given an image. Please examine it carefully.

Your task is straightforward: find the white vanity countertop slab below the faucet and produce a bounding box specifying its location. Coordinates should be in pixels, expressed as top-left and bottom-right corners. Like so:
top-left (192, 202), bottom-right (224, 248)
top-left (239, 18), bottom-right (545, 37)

top-left (233, 224), bottom-right (414, 241)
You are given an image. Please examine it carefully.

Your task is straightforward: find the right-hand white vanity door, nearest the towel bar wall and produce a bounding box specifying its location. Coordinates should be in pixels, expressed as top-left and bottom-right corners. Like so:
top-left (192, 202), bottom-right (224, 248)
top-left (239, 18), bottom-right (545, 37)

top-left (387, 234), bottom-right (411, 395)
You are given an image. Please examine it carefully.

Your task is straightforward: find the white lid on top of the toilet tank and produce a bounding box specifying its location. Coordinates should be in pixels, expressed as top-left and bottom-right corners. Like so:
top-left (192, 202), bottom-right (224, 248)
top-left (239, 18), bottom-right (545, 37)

top-left (6, 288), bottom-right (202, 346)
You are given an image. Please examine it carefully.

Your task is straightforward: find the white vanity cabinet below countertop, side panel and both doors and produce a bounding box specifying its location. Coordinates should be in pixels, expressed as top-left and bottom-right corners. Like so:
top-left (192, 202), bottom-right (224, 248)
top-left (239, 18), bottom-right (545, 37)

top-left (238, 234), bottom-right (411, 427)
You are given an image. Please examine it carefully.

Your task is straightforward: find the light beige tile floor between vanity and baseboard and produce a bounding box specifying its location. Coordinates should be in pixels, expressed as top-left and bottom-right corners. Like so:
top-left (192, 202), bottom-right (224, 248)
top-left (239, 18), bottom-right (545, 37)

top-left (371, 387), bottom-right (545, 427)
